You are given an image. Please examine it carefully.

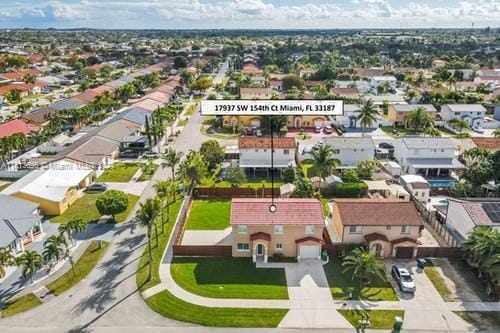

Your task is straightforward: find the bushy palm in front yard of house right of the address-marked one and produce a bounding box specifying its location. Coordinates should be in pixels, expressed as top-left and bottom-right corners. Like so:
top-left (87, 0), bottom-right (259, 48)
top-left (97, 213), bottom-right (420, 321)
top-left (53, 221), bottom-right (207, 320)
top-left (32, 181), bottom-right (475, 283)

top-left (342, 247), bottom-right (382, 292)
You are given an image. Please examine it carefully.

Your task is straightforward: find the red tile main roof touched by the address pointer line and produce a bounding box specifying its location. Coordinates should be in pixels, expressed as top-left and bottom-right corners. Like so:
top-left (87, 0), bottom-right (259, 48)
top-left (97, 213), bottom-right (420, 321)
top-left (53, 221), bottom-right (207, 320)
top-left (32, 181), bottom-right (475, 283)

top-left (231, 198), bottom-right (325, 225)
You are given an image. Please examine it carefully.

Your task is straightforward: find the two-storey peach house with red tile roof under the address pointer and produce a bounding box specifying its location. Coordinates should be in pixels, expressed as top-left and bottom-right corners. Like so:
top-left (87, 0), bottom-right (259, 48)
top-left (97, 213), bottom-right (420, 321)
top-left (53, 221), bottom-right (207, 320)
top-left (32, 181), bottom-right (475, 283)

top-left (231, 198), bottom-right (325, 262)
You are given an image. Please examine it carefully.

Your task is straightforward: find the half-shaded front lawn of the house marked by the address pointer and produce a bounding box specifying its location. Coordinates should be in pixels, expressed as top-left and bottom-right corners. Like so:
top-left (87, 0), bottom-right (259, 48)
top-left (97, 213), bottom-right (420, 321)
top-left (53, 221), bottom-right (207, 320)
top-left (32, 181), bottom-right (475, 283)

top-left (171, 257), bottom-right (288, 299)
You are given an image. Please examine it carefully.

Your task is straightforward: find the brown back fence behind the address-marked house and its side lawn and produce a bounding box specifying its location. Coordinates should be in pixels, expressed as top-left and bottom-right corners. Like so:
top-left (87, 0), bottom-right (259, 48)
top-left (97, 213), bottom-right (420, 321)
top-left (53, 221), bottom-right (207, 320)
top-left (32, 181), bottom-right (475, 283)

top-left (193, 187), bottom-right (280, 198)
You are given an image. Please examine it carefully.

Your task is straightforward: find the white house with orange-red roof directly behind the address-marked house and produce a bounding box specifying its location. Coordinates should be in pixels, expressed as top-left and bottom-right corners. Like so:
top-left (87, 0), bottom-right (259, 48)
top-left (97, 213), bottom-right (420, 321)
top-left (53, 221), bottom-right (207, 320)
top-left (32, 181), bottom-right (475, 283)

top-left (238, 136), bottom-right (297, 173)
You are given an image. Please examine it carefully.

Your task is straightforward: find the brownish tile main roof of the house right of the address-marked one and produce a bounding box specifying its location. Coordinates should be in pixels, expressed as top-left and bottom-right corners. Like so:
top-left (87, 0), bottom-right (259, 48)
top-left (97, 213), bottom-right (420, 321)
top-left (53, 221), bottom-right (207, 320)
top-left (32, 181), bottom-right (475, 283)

top-left (333, 198), bottom-right (422, 226)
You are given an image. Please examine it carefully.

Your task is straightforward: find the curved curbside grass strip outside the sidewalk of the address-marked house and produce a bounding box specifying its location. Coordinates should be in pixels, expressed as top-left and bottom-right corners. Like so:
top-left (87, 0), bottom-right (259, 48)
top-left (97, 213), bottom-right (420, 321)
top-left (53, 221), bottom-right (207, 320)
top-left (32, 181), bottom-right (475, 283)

top-left (146, 290), bottom-right (288, 327)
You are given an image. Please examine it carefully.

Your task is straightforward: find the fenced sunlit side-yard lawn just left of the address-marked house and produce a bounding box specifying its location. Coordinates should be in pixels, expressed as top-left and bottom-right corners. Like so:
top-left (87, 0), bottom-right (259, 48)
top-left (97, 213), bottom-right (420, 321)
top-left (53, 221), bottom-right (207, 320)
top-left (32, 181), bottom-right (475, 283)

top-left (186, 199), bottom-right (231, 230)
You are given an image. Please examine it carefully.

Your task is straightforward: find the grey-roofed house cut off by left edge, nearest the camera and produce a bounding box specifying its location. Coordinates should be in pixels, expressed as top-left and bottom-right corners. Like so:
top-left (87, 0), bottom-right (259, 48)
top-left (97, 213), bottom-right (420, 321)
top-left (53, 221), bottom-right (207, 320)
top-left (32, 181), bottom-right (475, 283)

top-left (0, 194), bottom-right (43, 254)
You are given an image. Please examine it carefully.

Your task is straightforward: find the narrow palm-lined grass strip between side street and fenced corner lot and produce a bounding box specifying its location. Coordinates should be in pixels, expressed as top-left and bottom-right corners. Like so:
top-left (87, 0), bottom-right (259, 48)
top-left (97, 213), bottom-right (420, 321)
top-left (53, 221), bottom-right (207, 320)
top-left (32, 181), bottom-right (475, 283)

top-left (136, 198), bottom-right (182, 291)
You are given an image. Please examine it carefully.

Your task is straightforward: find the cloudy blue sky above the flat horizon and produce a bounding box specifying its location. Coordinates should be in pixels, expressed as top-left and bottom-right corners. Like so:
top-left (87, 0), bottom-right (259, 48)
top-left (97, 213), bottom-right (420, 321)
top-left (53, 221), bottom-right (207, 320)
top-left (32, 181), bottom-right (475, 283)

top-left (0, 0), bottom-right (500, 29)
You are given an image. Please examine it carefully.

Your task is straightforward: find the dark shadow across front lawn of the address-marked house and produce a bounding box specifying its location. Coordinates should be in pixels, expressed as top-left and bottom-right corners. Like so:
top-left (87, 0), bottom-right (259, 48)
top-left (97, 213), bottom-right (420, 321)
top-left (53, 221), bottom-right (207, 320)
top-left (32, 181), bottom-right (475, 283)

top-left (173, 257), bottom-right (287, 287)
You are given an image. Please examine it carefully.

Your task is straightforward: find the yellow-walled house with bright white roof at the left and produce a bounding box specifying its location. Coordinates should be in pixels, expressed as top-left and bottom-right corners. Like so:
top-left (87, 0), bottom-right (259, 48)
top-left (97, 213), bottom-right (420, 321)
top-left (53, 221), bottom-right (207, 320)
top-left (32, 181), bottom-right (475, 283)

top-left (2, 160), bottom-right (94, 215)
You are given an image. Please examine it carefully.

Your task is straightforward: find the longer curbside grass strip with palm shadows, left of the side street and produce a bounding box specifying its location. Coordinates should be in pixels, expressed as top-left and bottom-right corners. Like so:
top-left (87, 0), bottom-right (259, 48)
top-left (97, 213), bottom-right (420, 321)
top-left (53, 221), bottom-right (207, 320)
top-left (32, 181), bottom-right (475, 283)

top-left (46, 241), bottom-right (108, 296)
